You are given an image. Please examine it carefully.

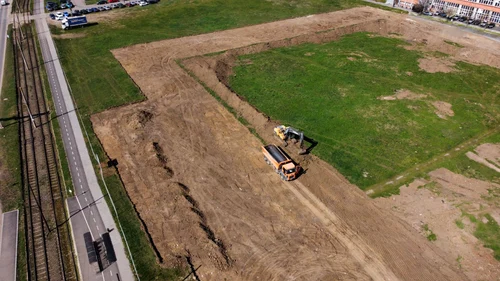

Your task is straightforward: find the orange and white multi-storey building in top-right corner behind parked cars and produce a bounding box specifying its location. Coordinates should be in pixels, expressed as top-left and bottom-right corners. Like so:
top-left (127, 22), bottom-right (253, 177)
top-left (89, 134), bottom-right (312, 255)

top-left (397, 0), bottom-right (500, 23)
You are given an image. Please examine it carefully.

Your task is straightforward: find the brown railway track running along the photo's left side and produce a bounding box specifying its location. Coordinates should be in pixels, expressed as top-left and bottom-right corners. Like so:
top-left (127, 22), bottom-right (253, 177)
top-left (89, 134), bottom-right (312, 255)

top-left (13, 8), bottom-right (78, 281)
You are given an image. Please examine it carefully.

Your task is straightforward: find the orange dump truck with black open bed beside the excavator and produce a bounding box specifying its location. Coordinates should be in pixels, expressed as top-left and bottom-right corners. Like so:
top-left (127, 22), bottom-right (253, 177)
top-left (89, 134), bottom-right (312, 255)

top-left (262, 144), bottom-right (301, 181)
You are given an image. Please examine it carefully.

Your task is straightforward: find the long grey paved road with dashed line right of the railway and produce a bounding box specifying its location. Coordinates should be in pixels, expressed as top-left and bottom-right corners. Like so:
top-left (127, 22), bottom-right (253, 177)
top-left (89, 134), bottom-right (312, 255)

top-left (34, 0), bottom-right (134, 281)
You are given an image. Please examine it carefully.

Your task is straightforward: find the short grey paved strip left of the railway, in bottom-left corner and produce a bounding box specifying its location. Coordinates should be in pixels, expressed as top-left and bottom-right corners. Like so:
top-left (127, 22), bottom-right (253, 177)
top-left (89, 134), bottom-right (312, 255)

top-left (0, 210), bottom-right (19, 281)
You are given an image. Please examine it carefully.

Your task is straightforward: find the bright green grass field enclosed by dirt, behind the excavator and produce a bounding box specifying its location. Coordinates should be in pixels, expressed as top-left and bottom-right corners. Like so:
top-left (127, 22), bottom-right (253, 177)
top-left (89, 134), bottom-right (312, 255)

top-left (230, 33), bottom-right (500, 192)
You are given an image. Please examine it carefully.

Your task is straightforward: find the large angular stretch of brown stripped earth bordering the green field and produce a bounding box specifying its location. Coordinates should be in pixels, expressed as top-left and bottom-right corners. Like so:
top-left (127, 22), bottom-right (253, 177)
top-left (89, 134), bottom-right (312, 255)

top-left (92, 7), bottom-right (500, 280)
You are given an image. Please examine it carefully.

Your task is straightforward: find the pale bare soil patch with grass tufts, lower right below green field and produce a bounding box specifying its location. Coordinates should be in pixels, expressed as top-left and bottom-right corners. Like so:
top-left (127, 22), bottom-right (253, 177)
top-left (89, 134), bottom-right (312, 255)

top-left (375, 169), bottom-right (500, 280)
